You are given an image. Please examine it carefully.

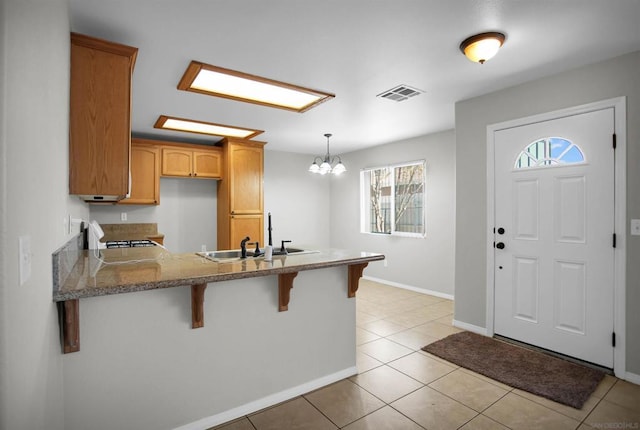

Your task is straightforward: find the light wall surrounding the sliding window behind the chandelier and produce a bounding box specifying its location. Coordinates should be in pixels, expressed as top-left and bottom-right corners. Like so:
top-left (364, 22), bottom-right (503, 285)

top-left (327, 130), bottom-right (455, 295)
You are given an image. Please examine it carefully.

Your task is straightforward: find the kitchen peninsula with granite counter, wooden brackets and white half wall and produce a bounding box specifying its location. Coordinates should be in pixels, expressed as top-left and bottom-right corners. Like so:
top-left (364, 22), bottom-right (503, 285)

top-left (53, 235), bottom-right (384, 429)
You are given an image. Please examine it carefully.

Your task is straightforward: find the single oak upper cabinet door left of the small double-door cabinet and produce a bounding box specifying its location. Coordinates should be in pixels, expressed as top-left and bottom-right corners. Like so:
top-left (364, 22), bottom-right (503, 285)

top-left (119, 144), bottom-right (160, 205)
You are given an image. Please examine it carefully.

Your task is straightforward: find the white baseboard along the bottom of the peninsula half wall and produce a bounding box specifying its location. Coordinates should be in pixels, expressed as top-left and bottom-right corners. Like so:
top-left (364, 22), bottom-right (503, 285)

top-left (174, 366), bottom-right (358, 430)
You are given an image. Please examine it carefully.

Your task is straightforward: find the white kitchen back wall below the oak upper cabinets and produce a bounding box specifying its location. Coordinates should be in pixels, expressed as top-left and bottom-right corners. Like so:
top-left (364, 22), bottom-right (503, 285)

top-left (91, 178), bottom-right (218, 253)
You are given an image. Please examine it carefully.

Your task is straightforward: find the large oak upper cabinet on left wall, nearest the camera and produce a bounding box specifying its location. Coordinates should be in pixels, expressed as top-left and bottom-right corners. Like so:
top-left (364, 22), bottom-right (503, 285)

top-left (69, 33), bottom-right (138, 201)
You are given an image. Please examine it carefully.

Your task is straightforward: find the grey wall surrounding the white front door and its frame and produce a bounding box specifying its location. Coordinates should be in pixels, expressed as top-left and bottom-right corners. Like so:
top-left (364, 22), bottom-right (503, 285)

top-left (455, 52), bottom-right (640, 375)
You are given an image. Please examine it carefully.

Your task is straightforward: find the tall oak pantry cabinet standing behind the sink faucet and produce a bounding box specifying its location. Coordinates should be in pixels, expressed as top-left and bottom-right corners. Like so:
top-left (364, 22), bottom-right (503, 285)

top-left (218, 139), bottom-right (265, 249)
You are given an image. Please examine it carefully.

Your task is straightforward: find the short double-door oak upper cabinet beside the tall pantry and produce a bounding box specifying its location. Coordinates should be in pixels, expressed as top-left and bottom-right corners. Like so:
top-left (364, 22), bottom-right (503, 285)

top-left (162, 147), bottom-right (222, 179)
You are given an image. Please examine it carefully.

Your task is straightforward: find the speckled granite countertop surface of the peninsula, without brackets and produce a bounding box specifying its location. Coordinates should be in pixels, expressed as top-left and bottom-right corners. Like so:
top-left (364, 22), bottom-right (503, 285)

top-left (53, 246), bottom-right (384, 302)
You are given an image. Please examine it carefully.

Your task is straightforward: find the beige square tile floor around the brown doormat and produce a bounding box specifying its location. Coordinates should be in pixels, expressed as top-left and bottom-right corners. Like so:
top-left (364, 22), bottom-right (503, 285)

top-left (215, 279), bottom-right (640, 430)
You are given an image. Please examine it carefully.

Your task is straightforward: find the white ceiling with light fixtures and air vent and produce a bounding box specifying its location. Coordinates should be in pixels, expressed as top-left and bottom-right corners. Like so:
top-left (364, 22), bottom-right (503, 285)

top-left (70, 0), bottom-right (640, 154)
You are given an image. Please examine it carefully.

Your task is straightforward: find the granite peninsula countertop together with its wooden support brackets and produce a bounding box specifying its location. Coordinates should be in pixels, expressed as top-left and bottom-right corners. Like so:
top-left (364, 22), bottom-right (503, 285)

top-left (53, 242), bottom-right (384, 352)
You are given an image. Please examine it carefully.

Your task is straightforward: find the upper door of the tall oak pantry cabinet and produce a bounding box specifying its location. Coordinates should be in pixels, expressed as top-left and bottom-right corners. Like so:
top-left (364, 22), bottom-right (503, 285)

top-left (229, 145), bottom-right (263, 214)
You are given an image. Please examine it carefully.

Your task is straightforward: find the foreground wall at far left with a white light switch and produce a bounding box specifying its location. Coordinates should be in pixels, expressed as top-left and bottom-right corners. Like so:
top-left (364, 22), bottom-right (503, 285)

top-left (0, 0), bottom-right (89, 430)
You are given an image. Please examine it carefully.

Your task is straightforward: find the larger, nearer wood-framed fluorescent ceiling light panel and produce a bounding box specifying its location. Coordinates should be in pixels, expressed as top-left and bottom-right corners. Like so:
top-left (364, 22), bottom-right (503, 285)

top-left (178, 61), bottom-right (335, 112)
